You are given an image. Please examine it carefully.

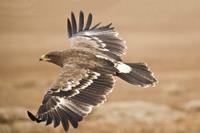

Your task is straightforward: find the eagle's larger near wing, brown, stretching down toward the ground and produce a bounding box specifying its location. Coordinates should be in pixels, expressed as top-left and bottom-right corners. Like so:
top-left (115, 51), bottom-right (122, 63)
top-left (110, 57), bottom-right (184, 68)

top-left (28, 67), bottom-right (114, 131)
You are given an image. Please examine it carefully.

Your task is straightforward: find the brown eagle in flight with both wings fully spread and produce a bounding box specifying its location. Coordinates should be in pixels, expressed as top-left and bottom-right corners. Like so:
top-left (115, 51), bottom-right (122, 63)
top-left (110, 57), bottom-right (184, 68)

top-left (27, 11), bottom-right (158, 132)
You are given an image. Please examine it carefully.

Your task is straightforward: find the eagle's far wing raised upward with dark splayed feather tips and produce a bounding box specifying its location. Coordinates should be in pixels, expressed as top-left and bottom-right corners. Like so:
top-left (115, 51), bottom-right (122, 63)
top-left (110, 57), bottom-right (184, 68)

top-left (67, 11), bottom-right (126, 59)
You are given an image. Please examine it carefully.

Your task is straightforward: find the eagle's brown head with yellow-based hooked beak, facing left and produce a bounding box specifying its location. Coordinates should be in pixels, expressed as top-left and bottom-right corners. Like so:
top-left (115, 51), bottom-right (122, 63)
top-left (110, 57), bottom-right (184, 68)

top-left (39, 51), bottom-right (63, 66)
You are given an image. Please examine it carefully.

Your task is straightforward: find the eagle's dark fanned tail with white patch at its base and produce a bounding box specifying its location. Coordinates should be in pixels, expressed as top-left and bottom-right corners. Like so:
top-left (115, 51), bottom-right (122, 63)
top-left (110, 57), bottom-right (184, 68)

top-left (115, 62), bottom-right (158, 87)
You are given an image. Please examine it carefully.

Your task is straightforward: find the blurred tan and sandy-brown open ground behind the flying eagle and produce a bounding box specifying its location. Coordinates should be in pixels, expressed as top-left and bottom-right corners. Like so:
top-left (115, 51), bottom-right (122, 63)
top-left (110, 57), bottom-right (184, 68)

top-left (0, 0), bottom-right (200, 133)
